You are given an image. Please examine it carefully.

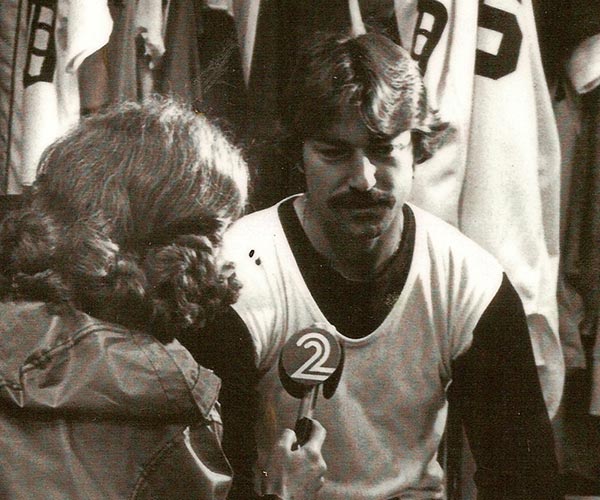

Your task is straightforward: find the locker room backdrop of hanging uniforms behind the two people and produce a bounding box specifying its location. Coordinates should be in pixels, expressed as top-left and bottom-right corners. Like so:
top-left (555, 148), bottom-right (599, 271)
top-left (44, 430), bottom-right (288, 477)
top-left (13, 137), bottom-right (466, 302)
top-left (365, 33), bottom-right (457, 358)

top-left (0, 0), bottom-right (600, 498)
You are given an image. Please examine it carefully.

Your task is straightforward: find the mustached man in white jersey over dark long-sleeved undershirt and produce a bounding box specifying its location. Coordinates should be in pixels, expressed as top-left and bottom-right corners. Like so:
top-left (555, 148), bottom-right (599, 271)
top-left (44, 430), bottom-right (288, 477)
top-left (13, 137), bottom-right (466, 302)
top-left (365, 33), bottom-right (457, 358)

top-left (184, 34), bottom-right (560, 500)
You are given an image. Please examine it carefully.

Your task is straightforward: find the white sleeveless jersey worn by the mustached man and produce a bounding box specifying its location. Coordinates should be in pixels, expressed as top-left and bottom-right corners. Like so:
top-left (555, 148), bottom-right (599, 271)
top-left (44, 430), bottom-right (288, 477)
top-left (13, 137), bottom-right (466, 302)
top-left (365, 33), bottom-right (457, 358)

top-left (224, 199), bottom-right (502, 500)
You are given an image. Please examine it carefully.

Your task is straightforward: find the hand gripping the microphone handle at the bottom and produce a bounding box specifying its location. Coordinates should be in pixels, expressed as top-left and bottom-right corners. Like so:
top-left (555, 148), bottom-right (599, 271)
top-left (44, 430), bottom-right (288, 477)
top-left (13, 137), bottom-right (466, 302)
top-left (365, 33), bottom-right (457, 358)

top-left (261, 419), bottom-right (327, 500)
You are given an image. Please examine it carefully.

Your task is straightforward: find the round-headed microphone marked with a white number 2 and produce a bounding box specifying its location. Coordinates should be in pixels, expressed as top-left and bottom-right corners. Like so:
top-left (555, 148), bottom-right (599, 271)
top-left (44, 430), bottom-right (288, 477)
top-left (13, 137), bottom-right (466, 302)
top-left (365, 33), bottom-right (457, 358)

top-left (279, 325), bottom-right (344, 450)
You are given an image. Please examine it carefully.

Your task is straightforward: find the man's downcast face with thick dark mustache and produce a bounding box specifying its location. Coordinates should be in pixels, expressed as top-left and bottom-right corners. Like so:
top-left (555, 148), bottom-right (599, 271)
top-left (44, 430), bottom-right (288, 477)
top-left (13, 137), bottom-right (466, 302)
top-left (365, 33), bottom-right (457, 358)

top-left (302, 110), bottom-right (413, 240)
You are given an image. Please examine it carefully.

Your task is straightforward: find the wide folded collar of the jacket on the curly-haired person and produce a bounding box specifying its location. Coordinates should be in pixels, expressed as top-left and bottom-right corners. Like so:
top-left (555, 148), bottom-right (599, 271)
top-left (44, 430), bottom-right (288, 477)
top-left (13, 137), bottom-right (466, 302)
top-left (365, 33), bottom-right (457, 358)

top-left (0, 302), bottom-right (221, 421)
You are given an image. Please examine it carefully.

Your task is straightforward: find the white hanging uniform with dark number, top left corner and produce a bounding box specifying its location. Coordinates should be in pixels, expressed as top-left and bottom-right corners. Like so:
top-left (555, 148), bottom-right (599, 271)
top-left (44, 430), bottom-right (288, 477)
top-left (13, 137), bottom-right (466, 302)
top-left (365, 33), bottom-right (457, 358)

top-left (7, 0), bottom-right (112, 194)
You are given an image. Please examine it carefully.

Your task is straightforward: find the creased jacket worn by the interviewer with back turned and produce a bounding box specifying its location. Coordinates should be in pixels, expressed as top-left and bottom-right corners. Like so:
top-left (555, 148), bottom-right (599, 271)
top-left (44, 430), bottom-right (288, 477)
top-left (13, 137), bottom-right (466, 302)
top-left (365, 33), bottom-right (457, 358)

top-left (0, 302), bottom-right (231, 500)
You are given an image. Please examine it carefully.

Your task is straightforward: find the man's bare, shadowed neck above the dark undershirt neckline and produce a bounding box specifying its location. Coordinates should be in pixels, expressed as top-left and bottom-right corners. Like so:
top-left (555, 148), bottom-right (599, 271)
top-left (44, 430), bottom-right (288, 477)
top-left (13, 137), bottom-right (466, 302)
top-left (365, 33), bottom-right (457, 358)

top-left (294, 195), bottom-right (402, 281)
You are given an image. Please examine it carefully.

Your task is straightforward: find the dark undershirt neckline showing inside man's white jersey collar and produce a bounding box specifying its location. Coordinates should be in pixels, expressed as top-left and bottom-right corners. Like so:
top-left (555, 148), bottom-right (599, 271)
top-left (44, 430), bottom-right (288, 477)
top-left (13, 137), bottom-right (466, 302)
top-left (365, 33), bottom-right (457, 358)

top-left (278, 198), bottom-right (415, 339)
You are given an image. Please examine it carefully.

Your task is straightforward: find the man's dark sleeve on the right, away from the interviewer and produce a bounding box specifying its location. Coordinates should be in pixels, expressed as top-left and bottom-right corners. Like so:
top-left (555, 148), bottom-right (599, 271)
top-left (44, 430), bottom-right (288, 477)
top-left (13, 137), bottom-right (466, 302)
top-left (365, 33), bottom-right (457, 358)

top-left (449, 276), bottom-right (563, 500)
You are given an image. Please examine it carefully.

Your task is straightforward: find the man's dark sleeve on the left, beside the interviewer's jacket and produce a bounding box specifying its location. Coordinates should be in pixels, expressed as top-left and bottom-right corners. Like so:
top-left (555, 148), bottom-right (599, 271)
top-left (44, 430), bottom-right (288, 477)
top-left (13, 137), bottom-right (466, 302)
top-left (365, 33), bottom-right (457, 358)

top-left (180, 308), bottom-right (259, 500)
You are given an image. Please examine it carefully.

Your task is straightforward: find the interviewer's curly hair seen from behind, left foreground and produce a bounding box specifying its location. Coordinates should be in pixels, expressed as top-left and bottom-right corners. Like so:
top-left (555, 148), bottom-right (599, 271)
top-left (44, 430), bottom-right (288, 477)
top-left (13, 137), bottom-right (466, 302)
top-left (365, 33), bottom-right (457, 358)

top-left (0, 97), bottom-right (248, 342)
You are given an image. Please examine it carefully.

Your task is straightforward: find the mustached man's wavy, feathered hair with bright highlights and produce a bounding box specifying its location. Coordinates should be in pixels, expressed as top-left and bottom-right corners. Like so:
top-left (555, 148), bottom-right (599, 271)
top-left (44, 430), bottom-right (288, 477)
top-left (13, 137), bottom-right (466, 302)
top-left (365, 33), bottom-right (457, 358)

top-left (283, 33), bottom-right (450, 163)
